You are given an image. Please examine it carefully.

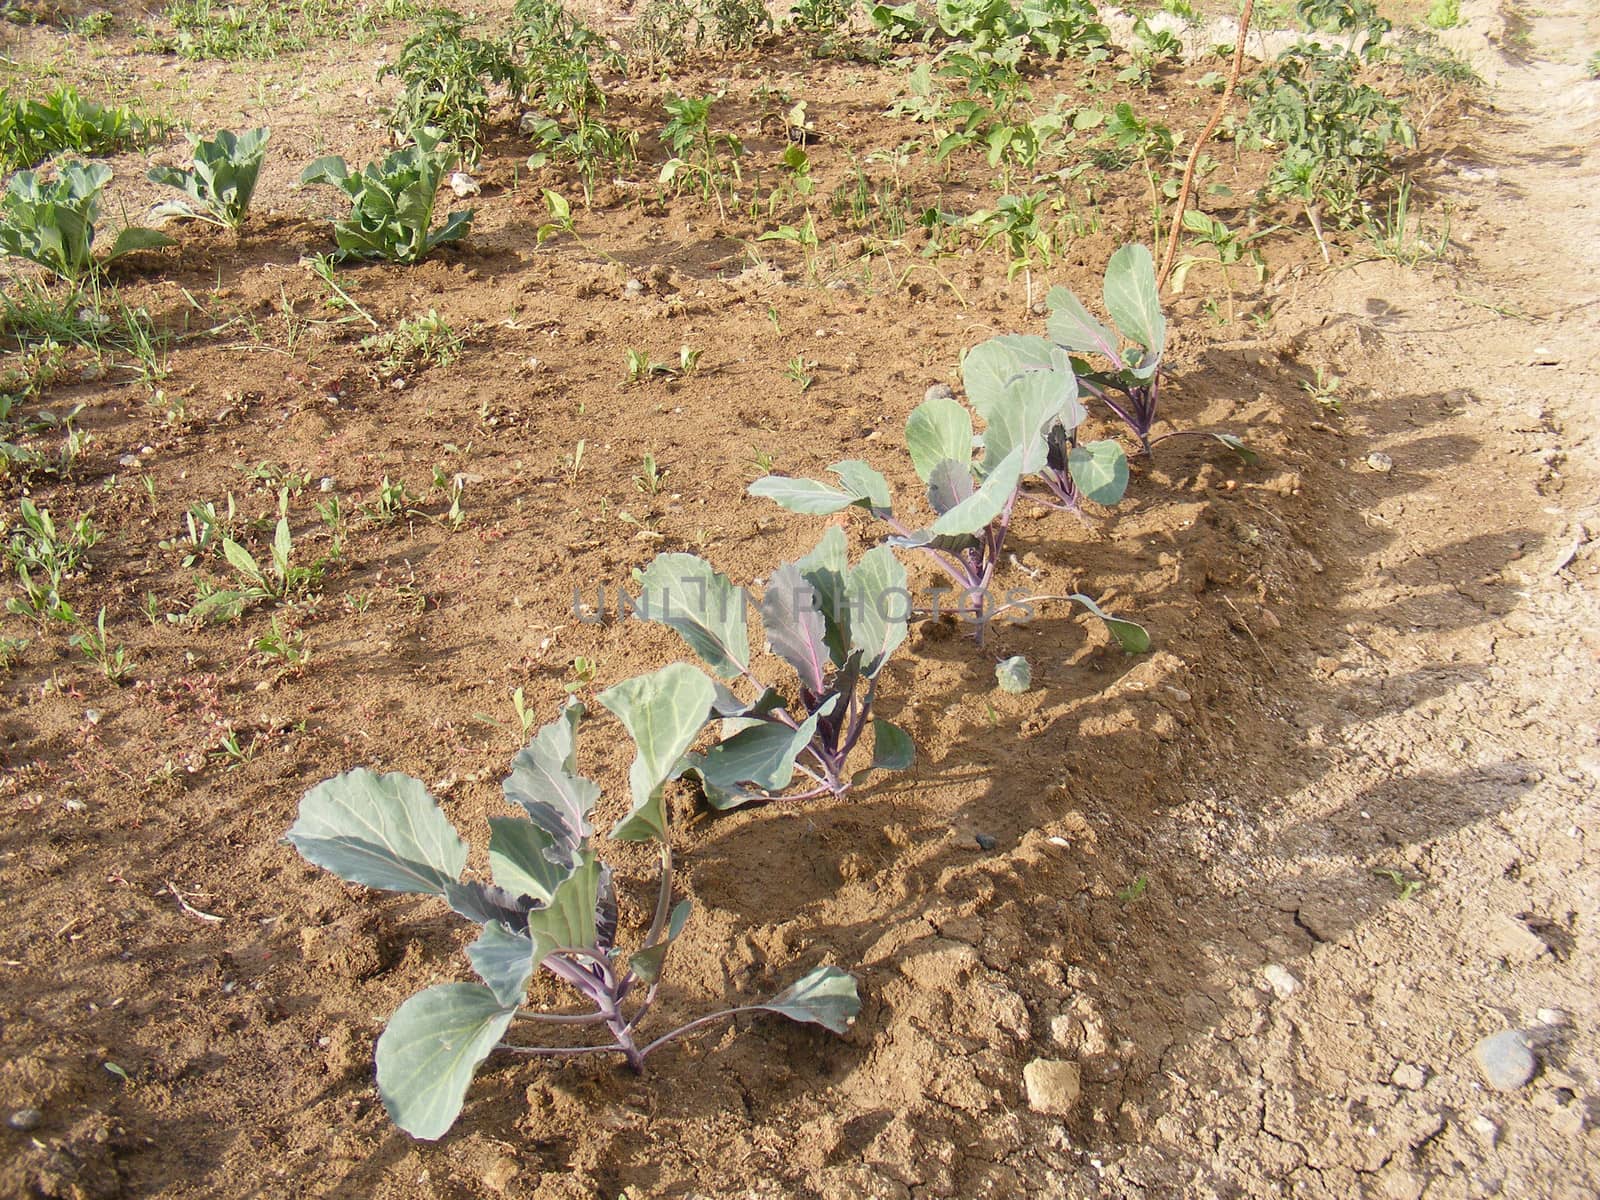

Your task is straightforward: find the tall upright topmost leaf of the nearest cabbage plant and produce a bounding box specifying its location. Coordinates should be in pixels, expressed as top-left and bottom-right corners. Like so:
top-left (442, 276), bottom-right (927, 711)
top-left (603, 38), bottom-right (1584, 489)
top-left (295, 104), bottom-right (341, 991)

top-left (597, 662), bottom-right (717, 842)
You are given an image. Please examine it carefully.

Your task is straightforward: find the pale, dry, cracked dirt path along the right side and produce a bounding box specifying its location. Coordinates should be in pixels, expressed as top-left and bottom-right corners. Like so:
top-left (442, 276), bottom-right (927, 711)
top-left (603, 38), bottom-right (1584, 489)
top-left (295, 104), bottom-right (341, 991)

top-left (1077, 0), bottom-right (1600, 1197)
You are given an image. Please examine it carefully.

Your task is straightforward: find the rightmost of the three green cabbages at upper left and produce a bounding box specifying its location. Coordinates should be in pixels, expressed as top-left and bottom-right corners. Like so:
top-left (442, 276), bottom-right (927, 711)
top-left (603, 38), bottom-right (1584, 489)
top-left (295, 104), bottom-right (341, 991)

top-left (301, 130), bottom-right (472, 264)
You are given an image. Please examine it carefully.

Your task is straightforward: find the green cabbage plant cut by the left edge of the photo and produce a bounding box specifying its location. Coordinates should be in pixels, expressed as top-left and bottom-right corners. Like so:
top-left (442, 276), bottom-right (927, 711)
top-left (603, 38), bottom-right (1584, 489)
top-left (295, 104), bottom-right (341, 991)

top-left (0, 162), bottom-right (173, 283)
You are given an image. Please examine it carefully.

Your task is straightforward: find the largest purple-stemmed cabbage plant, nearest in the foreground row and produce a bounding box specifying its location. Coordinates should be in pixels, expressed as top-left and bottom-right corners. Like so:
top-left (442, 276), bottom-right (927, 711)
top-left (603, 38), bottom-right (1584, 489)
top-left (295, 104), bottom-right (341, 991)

top-left (288, 662), bottom-right (861, 1139)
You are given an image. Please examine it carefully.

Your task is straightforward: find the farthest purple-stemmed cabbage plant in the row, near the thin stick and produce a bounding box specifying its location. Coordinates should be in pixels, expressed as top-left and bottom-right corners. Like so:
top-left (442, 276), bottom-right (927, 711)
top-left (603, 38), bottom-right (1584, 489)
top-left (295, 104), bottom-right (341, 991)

top-left (1036, 245), bottom-right (1254, 464)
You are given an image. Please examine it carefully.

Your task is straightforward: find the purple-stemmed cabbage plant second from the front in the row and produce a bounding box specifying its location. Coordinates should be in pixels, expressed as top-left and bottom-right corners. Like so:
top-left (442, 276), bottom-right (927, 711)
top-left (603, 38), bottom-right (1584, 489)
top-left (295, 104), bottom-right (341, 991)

top-left (634, 544), bottom-right (915, 808)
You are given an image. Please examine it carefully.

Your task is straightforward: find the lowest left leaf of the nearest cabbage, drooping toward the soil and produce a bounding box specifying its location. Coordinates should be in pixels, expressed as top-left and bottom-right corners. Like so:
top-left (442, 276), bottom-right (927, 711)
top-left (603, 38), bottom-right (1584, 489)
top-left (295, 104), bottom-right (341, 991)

top-left (378, 984), bottom-right (517, 1141)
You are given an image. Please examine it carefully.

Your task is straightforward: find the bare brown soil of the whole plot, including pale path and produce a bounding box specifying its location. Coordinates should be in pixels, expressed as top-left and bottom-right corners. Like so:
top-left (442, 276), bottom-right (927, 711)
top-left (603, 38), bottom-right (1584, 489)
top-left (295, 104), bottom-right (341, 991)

top-left (0, 0), bottom-right (1600, 1200)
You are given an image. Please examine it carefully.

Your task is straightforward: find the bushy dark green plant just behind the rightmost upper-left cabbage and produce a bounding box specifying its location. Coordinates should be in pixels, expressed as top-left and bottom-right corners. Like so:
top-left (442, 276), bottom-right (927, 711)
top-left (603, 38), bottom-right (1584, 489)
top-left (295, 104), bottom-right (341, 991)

top-left (378, 8), bottom-right (523, 162)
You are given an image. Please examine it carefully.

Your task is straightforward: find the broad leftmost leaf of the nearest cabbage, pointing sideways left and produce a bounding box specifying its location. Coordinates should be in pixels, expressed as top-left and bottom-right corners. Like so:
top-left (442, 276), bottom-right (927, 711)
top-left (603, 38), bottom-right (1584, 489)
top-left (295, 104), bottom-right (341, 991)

top-left (288, 766), bottom-right (467, 896)
